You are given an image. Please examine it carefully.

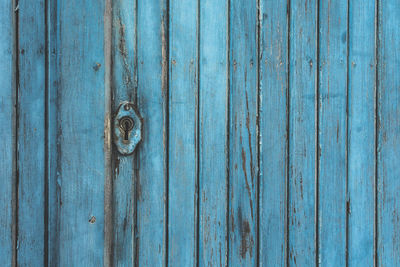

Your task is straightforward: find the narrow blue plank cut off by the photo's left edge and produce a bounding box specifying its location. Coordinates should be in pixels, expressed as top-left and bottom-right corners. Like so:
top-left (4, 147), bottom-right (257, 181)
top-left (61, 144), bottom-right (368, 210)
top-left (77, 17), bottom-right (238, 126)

top-left (0, 1), bottom-right (16, 266)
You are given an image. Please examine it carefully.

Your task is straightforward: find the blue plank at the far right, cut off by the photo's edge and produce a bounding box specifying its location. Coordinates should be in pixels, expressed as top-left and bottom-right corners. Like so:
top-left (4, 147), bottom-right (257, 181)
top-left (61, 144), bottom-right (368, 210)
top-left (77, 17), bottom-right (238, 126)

top-left (377, 0), bottom-right (400, 266)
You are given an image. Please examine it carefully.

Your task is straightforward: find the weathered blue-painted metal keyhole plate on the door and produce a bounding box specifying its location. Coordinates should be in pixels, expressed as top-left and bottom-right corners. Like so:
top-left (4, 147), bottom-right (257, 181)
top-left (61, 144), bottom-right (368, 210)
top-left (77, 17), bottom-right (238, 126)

top-left (114, 102), bottom-right (142, 155)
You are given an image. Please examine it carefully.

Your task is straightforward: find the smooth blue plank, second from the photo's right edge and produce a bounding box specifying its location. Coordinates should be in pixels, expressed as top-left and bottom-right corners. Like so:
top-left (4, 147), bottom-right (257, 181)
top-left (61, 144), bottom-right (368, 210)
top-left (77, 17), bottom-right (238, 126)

top-left (347, 0), bottom-right (376, 266)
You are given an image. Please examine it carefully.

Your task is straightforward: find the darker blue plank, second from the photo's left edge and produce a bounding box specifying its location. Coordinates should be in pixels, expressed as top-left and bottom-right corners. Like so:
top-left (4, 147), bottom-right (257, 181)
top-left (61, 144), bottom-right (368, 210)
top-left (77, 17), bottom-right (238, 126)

top-left (17, 0), bottom-right (46, 266)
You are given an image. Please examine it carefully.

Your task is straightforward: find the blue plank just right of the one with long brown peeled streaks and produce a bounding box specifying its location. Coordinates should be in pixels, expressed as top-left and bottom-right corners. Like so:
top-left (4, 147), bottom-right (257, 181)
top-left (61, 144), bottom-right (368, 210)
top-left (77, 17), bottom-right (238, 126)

top-left (260, 1), bottom-right (290, 266)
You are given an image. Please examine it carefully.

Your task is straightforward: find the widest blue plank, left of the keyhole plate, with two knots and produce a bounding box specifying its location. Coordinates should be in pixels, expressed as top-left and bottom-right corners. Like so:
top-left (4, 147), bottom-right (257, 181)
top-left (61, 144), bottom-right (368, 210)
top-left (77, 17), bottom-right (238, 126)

top-left (58, 0), bottom-right (106, 266)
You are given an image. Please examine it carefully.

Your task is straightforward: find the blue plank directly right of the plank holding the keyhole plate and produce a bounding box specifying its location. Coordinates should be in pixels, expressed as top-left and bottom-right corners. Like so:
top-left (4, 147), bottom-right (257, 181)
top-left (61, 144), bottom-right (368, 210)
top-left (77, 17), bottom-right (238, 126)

top-left (137, 0), bottom-right (168, 266)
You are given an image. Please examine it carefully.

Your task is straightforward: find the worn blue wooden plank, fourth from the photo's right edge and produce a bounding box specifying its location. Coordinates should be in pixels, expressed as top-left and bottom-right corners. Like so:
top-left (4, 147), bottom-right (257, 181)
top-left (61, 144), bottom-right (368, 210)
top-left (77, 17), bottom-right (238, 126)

top-left (289, 0), bottom-right (317, 266)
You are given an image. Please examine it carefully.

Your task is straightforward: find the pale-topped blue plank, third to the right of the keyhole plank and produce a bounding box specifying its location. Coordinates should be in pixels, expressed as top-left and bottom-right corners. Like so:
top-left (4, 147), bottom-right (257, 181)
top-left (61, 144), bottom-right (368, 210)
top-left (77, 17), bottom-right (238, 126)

top-left (199, 0), bottom-right (229, 266)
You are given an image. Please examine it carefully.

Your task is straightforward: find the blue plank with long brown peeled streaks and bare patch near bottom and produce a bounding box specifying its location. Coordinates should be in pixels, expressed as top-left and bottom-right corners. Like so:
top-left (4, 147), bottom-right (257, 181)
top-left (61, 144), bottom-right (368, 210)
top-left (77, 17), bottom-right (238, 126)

top-left (228, 0), bottom-right (258, 266)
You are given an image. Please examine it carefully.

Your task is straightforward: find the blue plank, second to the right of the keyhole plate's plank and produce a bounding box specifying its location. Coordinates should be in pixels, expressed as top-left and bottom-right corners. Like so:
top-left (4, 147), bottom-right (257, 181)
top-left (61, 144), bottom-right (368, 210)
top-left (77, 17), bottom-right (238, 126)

top-left (168, 0), bottom-right (198, 266)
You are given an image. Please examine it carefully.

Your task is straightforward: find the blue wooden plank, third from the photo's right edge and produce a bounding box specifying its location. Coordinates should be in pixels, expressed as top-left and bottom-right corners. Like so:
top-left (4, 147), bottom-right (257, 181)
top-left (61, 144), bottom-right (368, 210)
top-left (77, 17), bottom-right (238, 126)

top-left (318, 1), bottom-right (347, 266)
